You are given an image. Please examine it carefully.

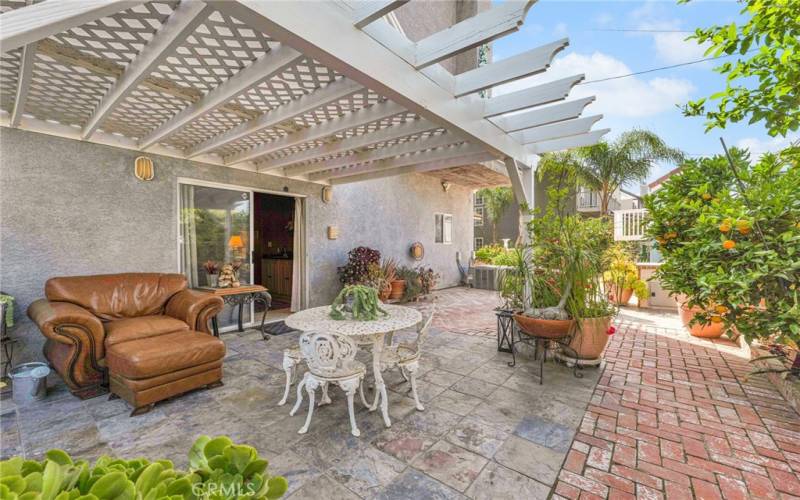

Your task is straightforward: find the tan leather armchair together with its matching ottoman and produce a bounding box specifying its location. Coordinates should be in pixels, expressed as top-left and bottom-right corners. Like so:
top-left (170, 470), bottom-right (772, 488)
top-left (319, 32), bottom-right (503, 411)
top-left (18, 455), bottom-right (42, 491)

top-left (28, 273), bottom-right (225, 413)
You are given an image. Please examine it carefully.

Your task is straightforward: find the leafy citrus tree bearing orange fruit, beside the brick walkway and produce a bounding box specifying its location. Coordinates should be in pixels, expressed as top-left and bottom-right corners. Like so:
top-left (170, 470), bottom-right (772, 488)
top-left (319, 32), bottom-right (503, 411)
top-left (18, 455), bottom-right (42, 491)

top-left (645, 148), bottom-right (800, 344)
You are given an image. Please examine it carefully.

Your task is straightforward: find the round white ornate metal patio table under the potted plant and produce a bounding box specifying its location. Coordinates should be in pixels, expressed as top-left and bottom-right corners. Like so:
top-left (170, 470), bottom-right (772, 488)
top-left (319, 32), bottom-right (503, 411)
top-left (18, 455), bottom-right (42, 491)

top-left (285, 304), bottom-right (422, 427)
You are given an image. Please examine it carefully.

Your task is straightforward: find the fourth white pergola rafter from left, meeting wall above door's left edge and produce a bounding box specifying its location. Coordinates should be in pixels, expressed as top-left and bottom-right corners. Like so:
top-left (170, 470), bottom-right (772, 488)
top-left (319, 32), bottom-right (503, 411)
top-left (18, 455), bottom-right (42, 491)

top-left (186, 78), bottom-right (363, 158)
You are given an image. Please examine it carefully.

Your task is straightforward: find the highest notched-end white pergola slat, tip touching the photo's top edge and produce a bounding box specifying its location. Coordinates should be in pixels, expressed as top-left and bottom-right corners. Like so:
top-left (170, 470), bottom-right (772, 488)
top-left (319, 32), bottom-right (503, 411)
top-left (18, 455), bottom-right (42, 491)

top-left (413, 0), bottom-right (535, 69)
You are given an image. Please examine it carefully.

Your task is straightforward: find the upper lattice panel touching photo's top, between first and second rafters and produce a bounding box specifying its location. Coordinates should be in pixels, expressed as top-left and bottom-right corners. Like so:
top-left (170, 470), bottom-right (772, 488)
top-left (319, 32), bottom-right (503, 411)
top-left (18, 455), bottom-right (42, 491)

top-left (50, 2), bottom-right (178, 66)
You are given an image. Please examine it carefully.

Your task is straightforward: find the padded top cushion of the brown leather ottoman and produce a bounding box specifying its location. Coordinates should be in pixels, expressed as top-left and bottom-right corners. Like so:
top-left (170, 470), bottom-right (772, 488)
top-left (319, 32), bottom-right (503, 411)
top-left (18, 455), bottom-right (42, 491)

top-left (106, 330), bottom-right (225, 380)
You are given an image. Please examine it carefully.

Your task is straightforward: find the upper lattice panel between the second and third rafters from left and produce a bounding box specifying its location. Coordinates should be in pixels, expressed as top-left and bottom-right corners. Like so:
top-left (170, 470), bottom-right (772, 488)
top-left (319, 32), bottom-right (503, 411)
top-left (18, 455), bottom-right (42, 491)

top-left (152, 11), bottom-right (275, 93)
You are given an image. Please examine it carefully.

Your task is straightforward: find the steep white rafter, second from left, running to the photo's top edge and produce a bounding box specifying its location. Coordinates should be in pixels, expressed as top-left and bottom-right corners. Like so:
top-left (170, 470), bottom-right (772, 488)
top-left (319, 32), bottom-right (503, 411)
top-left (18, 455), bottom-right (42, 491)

top-left (81, 2), bottom-right (214, 139)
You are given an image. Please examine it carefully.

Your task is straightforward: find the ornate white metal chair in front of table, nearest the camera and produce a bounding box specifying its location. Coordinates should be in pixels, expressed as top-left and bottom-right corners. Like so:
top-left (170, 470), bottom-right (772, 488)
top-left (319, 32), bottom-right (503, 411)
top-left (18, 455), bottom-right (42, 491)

top-left (289, 332), bottom-right (368, 437)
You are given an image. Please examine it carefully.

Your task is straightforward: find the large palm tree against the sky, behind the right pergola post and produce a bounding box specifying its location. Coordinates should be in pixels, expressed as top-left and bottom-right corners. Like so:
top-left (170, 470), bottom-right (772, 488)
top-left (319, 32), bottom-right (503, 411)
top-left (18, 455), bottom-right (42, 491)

top-left (539, 130), bottom-right (683, 215)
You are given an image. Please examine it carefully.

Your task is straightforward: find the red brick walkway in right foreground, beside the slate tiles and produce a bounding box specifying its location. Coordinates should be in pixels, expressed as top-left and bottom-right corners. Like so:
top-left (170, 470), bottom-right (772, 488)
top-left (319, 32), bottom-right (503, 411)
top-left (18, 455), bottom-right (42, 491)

top-left (555, 323), bottom-right (800, 499)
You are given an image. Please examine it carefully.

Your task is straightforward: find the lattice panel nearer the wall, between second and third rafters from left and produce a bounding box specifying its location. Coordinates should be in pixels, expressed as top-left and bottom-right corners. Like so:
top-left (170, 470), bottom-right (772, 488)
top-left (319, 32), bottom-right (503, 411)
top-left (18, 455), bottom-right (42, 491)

top-left (101, 85), bottom-right (189, 139)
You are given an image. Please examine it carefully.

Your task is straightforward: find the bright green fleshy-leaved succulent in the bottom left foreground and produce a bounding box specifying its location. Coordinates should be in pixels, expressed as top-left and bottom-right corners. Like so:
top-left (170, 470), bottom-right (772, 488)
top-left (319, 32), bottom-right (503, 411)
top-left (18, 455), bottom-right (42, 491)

top-left (0, 436), bottom-right (288, 500)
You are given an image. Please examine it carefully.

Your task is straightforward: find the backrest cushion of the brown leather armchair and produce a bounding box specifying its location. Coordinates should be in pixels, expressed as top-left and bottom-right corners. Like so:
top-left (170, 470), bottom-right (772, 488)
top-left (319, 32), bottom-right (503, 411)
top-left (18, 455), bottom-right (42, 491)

top-left (44, 273), bottom-right (186, 320)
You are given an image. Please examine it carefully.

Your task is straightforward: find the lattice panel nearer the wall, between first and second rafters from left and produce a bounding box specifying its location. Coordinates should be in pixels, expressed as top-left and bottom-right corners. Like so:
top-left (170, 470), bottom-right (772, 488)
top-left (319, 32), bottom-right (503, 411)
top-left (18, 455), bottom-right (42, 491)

top-left (25, 54), bottom-right (114, 125)
